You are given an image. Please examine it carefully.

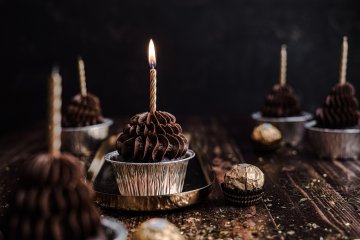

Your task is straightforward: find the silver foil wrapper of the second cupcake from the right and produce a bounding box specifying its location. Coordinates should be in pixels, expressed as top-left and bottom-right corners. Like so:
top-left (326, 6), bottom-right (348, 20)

top-left (251, 112), bottom-right (312, 146)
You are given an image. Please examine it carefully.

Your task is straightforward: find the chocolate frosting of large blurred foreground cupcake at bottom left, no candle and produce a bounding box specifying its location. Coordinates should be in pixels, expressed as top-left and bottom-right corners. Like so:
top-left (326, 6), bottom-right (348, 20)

top-left (3, 154), bottom-right (101, 240)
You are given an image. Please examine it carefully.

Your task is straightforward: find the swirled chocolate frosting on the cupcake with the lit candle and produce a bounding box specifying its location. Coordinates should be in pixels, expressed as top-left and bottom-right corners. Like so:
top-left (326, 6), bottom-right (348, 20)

top-left (116, 111), bottom-right (189, 162)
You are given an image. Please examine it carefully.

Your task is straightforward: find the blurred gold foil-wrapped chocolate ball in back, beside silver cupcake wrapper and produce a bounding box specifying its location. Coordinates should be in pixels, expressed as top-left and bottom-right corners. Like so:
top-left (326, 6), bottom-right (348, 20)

top-left (251, 123), bottom-right (282, 145)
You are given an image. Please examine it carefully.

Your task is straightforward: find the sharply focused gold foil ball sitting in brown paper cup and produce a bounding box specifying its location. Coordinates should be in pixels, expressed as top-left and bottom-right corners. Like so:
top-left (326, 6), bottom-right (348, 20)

top-left (224, 163), bottom-right (265, 191)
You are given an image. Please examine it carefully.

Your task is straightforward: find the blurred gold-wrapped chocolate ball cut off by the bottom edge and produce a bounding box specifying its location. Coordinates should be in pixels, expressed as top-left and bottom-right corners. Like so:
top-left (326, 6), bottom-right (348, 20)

top-left (133, 218), bottom-right (185, 240)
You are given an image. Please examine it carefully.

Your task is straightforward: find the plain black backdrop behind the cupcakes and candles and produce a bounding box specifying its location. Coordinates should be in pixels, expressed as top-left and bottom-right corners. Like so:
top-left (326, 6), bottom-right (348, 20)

top-left (0, 0), bottom-right (360, 133)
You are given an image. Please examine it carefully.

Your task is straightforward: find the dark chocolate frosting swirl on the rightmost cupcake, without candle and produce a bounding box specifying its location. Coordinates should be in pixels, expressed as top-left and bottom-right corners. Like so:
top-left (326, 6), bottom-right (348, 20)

top-left (316, 82), bottom-right (359, 128)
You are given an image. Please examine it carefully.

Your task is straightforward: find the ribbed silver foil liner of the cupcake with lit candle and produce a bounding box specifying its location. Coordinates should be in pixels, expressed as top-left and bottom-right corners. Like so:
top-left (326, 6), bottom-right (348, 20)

top-left (105, 150), bottom-right (195, 196)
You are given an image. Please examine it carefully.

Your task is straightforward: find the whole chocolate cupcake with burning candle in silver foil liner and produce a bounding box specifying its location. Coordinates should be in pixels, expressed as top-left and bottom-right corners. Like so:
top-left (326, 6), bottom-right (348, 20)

top-left (105, 41), bottom-right (195, 196)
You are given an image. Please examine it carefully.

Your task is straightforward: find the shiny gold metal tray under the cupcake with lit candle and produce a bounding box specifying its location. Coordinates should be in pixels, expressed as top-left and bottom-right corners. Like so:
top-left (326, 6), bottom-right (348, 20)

top-left (87, 136), bottom-right (214, 211)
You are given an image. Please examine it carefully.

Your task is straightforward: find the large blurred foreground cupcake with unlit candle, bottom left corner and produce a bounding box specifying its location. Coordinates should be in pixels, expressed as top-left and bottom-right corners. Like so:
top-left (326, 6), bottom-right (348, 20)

top-left (1, 70), bottom-right (127, 240)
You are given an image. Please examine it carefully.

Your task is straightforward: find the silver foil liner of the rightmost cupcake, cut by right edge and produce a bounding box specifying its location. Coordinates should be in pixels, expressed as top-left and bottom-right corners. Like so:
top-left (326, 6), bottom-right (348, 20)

top-left (305, 121), bottom-right (360, 159)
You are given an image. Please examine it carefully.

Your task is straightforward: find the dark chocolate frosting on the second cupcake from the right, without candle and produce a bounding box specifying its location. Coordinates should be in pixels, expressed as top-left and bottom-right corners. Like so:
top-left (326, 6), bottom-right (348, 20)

top-left (261, 84), bottom-right (301, 117)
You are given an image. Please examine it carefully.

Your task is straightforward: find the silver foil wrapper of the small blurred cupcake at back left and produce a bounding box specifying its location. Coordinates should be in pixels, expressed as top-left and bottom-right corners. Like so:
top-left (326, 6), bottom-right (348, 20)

top-left (61, 119), bottom-right (113, 157)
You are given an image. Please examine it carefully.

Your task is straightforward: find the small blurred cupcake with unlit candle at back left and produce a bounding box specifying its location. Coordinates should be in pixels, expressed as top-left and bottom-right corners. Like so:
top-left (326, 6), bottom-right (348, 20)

top-left (62, 58), bottom-right (113, 161)
